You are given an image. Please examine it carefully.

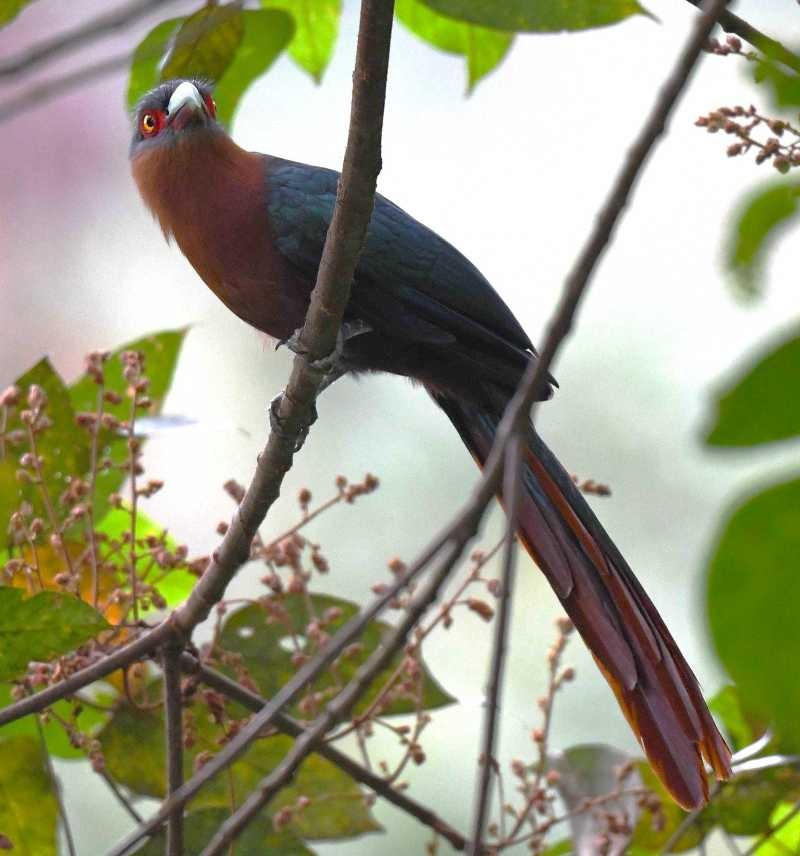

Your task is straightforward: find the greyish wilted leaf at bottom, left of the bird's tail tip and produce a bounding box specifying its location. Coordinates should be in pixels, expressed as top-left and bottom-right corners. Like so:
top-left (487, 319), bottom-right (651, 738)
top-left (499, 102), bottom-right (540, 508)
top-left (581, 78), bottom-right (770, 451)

top-left (548, 743), bottom-right (642, 856)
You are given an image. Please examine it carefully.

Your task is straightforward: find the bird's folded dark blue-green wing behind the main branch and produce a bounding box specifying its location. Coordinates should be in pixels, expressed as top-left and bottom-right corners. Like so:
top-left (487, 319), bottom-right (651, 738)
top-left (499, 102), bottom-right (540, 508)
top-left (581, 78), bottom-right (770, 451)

top-left (266, 158), bottom-right (533, 362)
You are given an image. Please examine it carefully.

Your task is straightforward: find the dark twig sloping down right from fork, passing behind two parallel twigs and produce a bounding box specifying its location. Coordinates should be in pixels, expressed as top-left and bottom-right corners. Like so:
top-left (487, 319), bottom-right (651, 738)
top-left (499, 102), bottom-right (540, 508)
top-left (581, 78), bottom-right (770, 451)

top-left (180, 653), bottom-right (466, 851)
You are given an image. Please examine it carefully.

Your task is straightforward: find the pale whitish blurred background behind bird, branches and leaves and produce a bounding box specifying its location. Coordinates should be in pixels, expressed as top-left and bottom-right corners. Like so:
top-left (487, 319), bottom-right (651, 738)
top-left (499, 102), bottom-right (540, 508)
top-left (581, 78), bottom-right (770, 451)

top-left (0, 0), bottom-right (800, 856)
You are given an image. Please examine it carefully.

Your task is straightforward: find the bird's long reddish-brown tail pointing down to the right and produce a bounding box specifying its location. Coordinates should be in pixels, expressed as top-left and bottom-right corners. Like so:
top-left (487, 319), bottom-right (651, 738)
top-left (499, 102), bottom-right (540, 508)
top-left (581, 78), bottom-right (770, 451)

top-left (433, 393), bottom-right (731, 809)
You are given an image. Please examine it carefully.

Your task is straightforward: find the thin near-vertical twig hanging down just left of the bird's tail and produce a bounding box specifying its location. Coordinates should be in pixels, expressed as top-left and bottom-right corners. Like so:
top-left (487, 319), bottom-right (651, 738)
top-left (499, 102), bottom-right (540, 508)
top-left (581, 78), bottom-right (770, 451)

top-left (470, 430), bottom-right (524, 856)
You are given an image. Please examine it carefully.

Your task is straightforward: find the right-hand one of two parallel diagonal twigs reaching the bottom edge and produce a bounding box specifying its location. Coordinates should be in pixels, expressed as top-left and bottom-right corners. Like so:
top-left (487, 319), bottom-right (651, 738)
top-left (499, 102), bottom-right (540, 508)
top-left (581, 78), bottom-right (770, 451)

top-left (200, 540), bottom-right (472, 856)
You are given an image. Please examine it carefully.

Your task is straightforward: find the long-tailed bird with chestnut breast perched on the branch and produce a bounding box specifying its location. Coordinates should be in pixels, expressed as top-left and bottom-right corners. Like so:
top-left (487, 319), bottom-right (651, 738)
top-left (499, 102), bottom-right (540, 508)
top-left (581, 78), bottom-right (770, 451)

top-left (130, 79), bottom-right (731, 809)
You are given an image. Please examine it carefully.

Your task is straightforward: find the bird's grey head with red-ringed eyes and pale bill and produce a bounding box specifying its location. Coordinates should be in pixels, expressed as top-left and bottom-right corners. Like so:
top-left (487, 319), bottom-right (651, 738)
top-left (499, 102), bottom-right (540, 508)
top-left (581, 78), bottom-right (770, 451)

top-left (130, 80), bottom-right (222, 160)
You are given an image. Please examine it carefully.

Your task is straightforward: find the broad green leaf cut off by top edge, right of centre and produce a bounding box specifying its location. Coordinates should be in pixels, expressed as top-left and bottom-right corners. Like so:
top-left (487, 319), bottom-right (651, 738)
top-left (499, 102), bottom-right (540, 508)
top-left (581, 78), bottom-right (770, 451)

top-left (416, 0), bottom-right (647, 33)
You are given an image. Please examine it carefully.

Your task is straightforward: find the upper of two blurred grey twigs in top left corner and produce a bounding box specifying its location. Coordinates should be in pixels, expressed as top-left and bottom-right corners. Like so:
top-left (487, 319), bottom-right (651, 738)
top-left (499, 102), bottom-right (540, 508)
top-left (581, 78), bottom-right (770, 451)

top-left (0, 0), bottom-right (183, 77)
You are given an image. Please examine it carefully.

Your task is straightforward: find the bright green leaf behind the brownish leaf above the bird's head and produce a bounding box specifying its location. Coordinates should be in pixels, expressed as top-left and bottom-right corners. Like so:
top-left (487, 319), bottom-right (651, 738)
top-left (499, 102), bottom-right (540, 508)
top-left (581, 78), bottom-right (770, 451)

top-left (128, 9), bottom-right (294, 125)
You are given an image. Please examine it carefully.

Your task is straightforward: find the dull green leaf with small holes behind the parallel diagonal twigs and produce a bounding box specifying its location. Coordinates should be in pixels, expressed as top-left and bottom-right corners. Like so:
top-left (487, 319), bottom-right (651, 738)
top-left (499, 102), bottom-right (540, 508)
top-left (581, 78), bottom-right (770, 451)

top-left (219, 594), bottom-right (453, 718)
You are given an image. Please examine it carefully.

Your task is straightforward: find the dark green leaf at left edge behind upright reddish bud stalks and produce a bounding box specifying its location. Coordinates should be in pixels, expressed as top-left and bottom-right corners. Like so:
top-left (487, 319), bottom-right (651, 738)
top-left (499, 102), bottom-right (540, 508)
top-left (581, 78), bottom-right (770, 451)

top-left (0, 358), bottom-right (89, 543)
